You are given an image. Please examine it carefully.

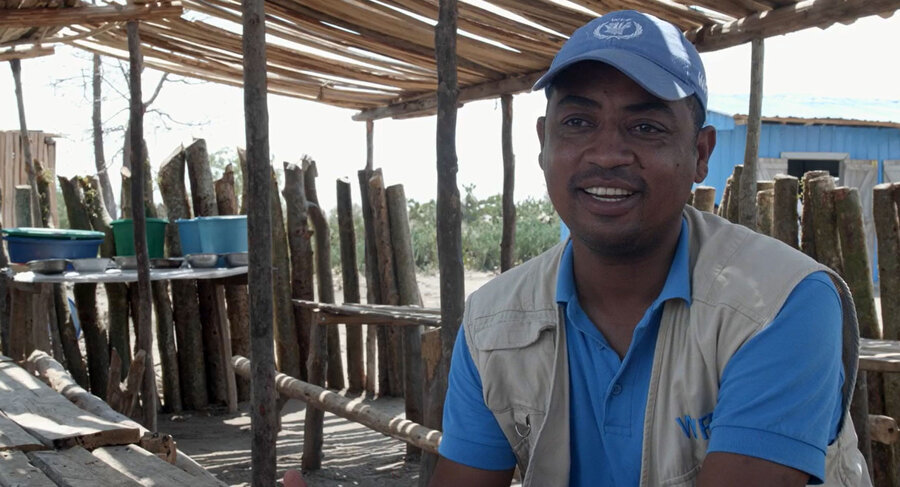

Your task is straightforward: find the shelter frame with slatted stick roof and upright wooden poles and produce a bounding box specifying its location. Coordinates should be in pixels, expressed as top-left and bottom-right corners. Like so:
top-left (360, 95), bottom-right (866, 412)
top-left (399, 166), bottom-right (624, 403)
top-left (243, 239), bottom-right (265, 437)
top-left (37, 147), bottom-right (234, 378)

top-left (0, 0), bottom-right (900, 485)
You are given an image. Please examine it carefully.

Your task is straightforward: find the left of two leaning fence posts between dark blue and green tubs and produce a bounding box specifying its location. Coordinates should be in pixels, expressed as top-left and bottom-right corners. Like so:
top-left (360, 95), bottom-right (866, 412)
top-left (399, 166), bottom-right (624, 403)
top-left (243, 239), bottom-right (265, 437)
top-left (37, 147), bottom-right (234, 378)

top-left (57, 177), bottom-right (109, 399)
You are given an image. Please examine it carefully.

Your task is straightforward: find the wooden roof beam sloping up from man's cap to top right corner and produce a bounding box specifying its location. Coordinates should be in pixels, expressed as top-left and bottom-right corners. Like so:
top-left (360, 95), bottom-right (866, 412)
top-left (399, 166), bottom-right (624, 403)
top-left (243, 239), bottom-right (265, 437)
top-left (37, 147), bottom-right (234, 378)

top-left (686, 0), bottom-right (900, 52)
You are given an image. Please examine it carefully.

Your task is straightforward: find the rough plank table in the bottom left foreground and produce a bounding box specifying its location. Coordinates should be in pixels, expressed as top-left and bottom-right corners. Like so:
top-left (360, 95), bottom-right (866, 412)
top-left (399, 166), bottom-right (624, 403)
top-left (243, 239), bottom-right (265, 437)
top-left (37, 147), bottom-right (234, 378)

top-left (0, 356), bottom-right (221, 487)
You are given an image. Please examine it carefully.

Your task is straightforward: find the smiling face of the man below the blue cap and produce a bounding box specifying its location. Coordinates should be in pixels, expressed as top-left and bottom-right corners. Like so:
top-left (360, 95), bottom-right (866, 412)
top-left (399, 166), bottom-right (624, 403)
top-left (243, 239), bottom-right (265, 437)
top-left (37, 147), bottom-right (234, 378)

top-left (537, 62), bottom-right (715, 257)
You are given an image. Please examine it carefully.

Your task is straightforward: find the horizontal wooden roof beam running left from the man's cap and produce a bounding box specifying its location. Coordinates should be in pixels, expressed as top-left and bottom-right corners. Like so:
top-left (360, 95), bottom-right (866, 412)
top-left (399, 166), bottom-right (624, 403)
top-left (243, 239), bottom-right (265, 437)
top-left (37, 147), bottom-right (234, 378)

top-left (353, 71), bottom-right (544, 121)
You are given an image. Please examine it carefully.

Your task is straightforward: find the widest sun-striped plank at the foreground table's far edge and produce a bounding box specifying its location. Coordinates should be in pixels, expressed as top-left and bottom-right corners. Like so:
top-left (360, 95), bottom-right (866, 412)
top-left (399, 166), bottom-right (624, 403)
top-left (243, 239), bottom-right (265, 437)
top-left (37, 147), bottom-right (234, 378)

top-left (0, 362), bottom-right (140, 448)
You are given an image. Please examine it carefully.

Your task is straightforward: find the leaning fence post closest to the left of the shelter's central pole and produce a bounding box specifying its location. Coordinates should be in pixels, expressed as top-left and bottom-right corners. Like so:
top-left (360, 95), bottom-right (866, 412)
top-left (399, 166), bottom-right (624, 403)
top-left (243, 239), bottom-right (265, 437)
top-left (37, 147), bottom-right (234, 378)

top-left (385, 184), bottom-right (424, 460)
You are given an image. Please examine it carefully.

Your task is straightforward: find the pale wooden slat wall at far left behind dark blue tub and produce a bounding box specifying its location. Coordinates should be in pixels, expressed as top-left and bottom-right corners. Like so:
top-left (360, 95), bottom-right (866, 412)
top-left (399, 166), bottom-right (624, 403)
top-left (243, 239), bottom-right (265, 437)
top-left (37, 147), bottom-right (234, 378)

top-left (0, 130), bottom-right (59, 228)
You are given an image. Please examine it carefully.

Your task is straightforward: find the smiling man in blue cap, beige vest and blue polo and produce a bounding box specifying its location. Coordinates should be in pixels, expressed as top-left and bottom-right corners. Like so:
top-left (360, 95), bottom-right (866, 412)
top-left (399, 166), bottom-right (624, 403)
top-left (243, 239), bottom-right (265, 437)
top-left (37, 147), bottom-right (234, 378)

top-left (431, 11), bottom-right (869, 487)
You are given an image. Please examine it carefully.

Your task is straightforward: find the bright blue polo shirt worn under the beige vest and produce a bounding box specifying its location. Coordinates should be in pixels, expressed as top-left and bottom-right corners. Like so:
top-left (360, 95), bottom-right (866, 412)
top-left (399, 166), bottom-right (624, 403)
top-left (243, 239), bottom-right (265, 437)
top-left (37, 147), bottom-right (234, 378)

top-left (439, 223), bottom-right (843, 486)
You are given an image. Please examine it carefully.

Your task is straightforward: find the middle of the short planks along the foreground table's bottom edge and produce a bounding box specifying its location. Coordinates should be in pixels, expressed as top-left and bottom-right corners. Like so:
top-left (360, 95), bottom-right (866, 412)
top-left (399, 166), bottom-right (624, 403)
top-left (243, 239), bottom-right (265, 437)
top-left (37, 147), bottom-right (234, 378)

top-left (28, 446), bottom-right (141, 487)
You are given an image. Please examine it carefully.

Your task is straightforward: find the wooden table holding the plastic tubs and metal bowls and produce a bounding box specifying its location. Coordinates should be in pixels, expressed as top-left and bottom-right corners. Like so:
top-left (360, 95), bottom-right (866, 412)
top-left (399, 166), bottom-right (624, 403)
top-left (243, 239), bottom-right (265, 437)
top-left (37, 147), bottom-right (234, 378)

top-left (8, 266), bottom-right (247, 412)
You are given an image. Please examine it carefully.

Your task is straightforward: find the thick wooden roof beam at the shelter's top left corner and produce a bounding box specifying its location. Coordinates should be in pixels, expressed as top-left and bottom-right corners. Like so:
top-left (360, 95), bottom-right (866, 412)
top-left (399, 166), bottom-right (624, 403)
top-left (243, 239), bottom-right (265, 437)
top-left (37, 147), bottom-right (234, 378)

top-left (0, 1), bottom-right (183, 27)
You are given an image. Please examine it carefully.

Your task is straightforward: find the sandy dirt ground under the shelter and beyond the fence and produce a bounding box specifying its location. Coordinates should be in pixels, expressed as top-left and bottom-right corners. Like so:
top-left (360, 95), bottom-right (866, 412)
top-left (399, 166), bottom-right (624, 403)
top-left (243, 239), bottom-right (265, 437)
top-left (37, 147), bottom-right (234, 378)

top-left (149, 272), bottom-right (494, 487)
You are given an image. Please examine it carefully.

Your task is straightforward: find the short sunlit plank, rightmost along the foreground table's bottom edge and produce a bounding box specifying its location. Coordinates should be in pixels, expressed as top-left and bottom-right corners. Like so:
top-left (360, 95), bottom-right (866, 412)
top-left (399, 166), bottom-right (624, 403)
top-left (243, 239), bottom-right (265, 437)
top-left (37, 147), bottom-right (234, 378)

top-left (92, 445), bottom-right (215, 487)
